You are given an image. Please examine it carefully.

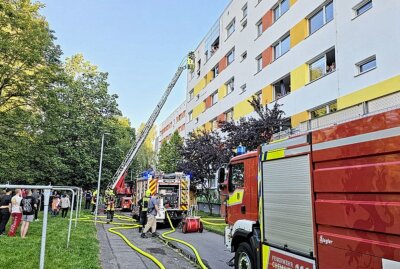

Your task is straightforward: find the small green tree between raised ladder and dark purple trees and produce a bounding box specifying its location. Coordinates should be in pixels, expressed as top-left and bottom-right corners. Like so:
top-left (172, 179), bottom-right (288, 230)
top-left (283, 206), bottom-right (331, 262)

top-left (158, 131), bottom-right (183, 173)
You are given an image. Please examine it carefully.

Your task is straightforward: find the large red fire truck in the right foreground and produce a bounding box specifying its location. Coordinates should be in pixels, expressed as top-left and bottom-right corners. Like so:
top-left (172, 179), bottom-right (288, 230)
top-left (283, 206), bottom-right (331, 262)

top-left (217, 93), bottom-right (400, 269)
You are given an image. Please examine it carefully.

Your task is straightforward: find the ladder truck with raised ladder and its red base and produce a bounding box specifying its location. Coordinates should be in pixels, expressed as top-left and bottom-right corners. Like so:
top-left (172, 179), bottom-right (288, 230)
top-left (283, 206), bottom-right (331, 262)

top-left (108, 52), bottom-right (195, 208)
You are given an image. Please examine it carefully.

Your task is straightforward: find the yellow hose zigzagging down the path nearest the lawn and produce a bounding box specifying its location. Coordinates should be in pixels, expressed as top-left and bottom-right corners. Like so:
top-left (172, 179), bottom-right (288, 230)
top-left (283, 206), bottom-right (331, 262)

top-left (78, 215), bottom-right (165, 269)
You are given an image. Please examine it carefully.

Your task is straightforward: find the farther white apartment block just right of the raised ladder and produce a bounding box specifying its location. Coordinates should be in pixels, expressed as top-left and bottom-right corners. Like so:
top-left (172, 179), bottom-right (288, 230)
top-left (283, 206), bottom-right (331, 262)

top-left (157, 101), bottom-right (186, 145)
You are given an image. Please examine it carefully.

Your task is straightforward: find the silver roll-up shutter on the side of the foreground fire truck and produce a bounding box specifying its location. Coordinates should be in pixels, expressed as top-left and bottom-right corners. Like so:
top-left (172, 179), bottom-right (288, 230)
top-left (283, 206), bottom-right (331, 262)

top-left (262, 155), bottom-right (314, 256)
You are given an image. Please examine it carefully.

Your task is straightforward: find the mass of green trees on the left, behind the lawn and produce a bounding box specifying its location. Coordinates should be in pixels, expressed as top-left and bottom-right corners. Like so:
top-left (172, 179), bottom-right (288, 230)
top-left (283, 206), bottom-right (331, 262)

top-left (0, 0), bottom-right (135, 187)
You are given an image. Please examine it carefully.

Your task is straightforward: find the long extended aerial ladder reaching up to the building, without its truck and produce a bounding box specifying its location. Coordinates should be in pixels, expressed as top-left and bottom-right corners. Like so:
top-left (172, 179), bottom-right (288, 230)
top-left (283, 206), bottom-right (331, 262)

top-left (109, 52), bottom-right (194, 189)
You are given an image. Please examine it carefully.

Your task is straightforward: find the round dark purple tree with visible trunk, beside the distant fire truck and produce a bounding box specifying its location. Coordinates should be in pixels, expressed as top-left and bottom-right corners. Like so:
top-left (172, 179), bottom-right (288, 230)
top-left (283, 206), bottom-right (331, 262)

top-left (179, 131), bottom-right (231, 215)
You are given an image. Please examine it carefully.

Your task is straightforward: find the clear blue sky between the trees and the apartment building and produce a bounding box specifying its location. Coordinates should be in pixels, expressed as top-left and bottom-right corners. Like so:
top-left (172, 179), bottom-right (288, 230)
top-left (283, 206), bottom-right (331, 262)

top-left (40, 0), bottom-right (230, 128)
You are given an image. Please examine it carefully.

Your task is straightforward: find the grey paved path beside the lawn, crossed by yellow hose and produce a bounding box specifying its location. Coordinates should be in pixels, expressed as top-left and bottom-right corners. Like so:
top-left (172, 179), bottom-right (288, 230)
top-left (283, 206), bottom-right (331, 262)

top-left (97, 224), bottom-right (195, 269)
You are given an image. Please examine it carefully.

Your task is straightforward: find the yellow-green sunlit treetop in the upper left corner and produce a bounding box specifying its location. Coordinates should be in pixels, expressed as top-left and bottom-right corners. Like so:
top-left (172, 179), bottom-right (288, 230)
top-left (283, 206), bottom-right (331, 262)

top-left (0, 0), bottom-right (61, 112)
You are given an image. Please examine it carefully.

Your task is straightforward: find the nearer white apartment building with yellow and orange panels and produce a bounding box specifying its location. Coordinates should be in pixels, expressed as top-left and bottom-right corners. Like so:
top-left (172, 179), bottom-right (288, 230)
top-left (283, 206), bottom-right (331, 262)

top-left (185, 0), bottom-right (400, 136)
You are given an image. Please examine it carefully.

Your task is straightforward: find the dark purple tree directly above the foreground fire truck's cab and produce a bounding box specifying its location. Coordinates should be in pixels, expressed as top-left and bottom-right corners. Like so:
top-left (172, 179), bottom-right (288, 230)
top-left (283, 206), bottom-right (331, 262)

top-left (221, 96), bottom-right (290, 150)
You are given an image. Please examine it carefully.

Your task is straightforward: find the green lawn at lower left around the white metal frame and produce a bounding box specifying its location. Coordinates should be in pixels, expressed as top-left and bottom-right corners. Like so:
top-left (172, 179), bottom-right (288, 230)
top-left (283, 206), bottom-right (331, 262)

top-left (0, 212), bottom-right (101, 269)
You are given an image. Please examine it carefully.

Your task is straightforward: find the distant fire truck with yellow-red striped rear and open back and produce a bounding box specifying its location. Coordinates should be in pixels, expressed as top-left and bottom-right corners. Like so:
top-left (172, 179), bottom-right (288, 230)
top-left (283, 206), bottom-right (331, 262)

top-left (133, 172), bottom-right (190, 224)
